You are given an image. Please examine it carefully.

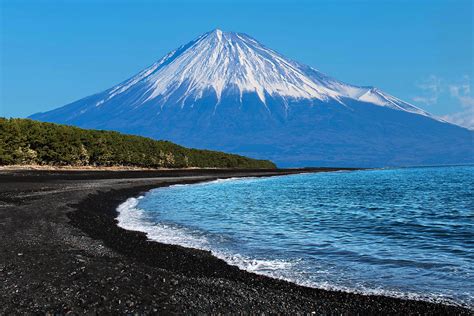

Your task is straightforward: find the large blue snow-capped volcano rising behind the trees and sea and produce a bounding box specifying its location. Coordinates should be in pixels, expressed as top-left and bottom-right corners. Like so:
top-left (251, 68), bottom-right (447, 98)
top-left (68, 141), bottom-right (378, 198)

top-left (30, 29), bottom-right (474, 167)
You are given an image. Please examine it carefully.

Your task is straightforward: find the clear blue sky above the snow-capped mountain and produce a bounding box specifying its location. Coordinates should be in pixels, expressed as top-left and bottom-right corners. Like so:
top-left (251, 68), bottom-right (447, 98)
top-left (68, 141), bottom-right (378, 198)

top-left (0, 0), bottom-right (474, 127)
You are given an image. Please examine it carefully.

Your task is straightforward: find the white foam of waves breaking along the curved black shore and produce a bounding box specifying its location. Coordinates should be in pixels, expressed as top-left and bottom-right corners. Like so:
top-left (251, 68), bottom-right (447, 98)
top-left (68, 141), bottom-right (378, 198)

top-left (117, 195), bottom-right (472, 307)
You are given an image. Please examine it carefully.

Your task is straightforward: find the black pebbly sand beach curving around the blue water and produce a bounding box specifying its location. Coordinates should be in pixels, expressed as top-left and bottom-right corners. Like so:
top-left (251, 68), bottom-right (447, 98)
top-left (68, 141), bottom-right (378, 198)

top-left (0, 170), bottom-right (473, 315)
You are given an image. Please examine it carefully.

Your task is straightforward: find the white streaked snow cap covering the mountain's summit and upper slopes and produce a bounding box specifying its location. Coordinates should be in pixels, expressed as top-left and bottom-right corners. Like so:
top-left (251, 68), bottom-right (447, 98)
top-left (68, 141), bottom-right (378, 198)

top-left (96, 28), bottom-right (436, 119)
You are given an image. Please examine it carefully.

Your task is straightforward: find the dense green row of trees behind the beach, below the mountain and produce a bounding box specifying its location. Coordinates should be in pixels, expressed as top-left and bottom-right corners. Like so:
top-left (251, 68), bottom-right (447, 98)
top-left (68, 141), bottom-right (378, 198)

top-left (0, 118), bottom-right (275, 168)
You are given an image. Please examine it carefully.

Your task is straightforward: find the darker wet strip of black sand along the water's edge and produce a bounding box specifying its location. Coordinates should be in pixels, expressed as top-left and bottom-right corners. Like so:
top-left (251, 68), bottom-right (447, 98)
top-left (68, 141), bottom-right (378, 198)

top-left (70, 175), bottom-right (470, 314)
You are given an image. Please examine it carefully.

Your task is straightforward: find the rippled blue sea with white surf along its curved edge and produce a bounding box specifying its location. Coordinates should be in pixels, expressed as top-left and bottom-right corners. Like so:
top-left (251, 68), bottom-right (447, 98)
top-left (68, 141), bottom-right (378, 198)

top-left (118, 166), bottom-right (474, 307)
